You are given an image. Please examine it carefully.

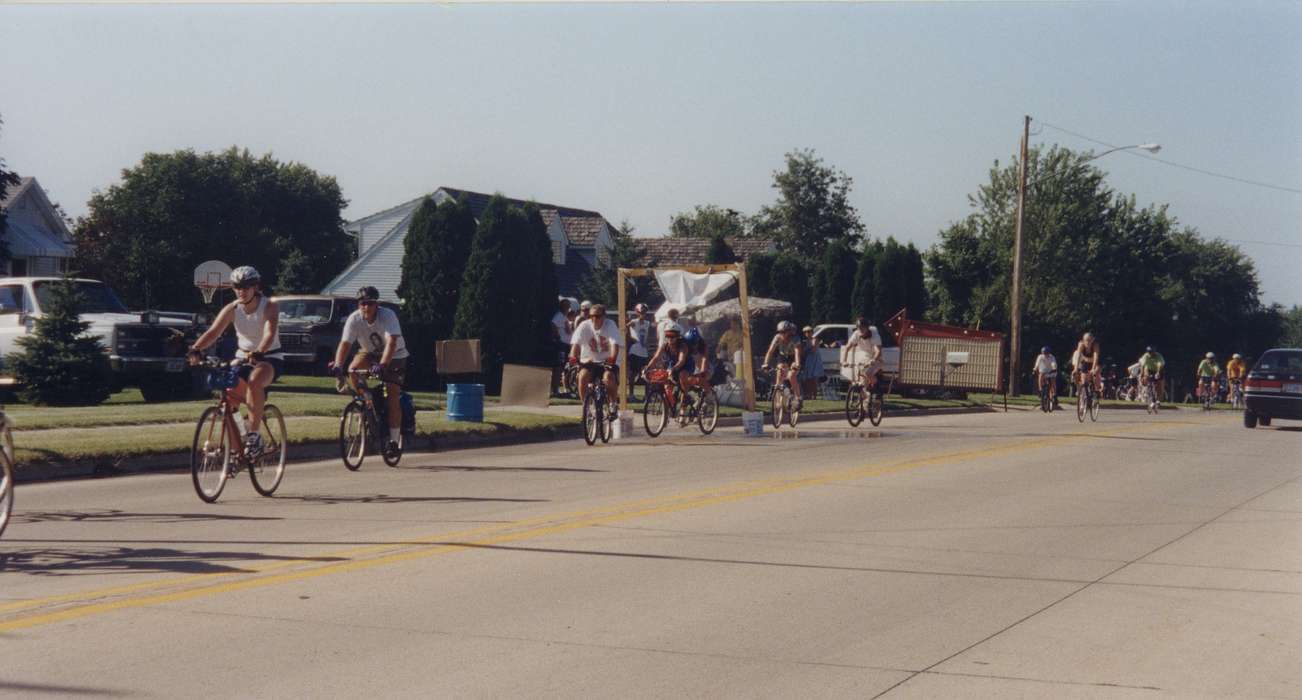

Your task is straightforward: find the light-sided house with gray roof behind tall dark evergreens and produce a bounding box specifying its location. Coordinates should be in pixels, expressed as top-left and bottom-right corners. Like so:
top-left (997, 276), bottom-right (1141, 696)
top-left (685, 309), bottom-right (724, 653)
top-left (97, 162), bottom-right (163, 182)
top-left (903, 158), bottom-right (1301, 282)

top-left (322, 187), bottom-right (615, 302)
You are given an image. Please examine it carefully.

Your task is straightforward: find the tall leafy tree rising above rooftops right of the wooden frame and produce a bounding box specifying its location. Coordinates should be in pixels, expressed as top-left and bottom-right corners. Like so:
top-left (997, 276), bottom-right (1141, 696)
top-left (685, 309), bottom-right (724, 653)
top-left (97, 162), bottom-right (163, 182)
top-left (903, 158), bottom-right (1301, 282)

top-left (751, 150), bottom-right (863, 263)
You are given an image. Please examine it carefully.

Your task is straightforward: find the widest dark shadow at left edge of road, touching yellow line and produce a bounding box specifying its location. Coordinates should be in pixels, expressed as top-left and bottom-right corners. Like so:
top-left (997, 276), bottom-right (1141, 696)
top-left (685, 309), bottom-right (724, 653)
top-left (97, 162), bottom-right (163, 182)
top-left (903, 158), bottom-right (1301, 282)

top-left (0, 546), bottom-right (344, 576)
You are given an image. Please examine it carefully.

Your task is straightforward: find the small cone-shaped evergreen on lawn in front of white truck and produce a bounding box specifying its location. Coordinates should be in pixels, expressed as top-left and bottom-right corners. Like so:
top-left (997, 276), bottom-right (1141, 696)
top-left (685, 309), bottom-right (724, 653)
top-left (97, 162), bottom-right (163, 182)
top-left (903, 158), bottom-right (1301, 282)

top-left (5, 277), bottom-right (112, 406)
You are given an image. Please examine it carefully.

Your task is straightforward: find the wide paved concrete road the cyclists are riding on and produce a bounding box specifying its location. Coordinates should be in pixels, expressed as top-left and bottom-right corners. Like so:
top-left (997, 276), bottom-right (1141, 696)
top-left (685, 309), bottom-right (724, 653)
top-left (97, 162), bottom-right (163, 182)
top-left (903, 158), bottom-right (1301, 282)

top-left (0, 411), bottom-right (1302, 699)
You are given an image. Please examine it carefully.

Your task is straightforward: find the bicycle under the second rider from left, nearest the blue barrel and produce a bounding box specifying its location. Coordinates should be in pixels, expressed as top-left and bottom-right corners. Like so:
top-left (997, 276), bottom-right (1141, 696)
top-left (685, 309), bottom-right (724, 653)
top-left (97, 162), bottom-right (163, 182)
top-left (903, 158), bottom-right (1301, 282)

top-left (335, 370), bottom-right (415, 471)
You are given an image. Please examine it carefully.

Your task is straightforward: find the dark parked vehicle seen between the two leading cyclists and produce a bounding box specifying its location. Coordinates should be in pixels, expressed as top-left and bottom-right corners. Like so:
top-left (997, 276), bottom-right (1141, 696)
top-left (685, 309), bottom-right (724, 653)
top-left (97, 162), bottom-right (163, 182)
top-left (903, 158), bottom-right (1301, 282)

top-left (273, 294), bottom-right (398, 375)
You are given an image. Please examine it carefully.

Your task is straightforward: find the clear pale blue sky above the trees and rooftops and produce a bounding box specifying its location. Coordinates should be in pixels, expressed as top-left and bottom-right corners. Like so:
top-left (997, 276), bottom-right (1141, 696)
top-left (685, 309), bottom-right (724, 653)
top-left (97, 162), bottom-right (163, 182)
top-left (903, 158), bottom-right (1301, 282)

top-left (0, 1), bottom-right (1302, 304)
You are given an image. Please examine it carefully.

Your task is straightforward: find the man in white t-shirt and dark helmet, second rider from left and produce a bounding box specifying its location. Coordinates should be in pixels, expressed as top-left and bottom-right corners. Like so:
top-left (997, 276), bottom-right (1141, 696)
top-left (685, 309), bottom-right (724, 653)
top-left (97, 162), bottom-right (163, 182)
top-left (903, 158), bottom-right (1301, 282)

top-left (331, 286), bottom-right (408, 449)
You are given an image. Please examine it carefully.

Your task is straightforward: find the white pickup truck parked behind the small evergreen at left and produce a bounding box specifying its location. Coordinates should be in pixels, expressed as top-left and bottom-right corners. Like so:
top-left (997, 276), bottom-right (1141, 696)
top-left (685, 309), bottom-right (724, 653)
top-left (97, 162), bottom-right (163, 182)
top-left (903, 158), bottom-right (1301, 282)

top-left (0, 277), bottom-right (198, 401)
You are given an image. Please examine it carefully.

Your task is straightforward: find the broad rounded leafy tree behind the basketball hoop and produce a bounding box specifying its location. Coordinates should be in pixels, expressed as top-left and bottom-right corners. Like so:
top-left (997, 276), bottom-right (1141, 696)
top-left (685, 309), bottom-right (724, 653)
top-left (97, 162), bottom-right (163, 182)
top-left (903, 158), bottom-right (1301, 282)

top-left (74, 148), bottom-right (353, 310)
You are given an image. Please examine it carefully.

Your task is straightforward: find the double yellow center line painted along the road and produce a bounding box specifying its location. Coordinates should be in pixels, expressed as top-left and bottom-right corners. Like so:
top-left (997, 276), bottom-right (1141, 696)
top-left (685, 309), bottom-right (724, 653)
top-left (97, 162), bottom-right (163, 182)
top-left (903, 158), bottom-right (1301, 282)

top-left (0, 422), bottom-right (1187, 632)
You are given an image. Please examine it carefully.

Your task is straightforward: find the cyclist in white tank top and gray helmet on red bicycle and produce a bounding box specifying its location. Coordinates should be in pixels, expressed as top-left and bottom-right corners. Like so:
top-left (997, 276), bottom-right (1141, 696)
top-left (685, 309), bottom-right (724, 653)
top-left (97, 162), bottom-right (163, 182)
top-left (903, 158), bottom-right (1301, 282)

top-left (187, 265), bottom-right (285, 458)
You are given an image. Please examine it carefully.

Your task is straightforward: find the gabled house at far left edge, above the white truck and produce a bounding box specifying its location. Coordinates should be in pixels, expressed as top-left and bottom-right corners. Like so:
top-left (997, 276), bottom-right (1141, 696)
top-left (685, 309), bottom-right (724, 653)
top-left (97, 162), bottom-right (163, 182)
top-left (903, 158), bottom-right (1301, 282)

top-left (0, 177), bottom-right (76, 277)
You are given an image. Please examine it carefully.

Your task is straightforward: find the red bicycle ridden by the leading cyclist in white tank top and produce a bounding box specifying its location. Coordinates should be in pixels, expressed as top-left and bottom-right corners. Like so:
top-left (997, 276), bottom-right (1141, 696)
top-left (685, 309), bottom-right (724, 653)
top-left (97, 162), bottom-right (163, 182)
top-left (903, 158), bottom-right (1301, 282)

top-left (190, 358), bottom-right (289, 504)
